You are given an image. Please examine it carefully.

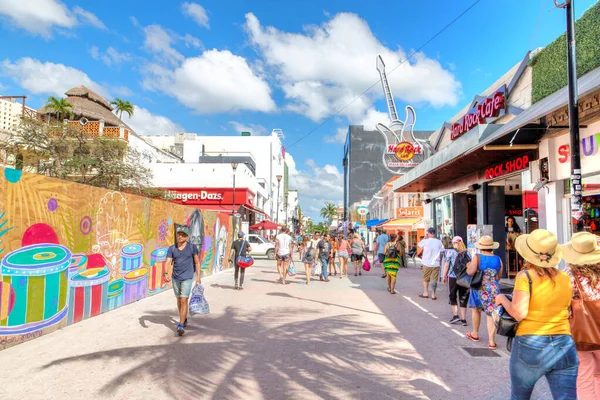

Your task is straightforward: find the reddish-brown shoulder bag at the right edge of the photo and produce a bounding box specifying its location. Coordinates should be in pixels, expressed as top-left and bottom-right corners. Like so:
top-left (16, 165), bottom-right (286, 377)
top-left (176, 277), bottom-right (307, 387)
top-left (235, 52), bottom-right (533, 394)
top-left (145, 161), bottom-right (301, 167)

top-left (569, 274), bottom-right (600, 351)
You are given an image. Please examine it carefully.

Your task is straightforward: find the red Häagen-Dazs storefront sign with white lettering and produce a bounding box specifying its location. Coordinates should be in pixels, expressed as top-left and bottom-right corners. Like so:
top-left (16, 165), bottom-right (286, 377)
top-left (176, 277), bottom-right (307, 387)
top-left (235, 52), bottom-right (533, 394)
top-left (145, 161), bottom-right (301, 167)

top-left (165, 188), bottom-right (254, 206)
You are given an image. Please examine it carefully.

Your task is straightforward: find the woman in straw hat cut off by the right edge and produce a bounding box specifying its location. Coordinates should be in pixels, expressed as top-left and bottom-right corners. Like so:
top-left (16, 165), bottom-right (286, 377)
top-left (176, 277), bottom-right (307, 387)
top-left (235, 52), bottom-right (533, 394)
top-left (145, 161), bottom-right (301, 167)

top-left (561, 232), bottom-right (600, 400)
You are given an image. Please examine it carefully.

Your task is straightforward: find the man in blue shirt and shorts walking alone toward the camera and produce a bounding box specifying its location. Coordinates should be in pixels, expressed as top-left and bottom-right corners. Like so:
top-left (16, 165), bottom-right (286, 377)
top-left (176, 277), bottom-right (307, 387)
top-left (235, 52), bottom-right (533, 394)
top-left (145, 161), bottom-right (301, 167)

top-left (165, 226), bottom-right (202, 336)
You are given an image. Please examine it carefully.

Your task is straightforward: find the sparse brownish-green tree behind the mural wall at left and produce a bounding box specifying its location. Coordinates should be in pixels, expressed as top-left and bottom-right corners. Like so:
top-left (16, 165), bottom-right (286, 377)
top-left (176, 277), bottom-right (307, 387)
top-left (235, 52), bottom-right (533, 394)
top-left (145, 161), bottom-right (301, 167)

top-left (0, 118), bottom-right (152, 193)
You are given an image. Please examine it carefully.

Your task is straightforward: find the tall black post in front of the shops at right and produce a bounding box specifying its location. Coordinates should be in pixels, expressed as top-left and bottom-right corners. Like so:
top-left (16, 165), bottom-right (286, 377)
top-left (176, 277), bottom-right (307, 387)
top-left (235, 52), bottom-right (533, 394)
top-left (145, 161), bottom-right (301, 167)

top-left (554, 0), bottom-right (583, 233)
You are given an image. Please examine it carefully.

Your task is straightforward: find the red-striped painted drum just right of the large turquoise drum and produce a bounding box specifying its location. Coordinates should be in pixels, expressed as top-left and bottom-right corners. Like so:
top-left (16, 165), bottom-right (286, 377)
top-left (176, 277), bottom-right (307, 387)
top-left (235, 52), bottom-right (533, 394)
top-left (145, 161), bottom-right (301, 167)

top-left (68, 267), bottom-right (110, 324)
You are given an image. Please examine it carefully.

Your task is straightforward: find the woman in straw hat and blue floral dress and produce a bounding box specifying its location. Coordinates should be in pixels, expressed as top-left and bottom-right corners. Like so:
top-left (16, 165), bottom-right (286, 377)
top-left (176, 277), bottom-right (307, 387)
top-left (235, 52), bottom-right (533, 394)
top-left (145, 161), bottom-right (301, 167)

top-left (466, 236), bottom-right (502, 350)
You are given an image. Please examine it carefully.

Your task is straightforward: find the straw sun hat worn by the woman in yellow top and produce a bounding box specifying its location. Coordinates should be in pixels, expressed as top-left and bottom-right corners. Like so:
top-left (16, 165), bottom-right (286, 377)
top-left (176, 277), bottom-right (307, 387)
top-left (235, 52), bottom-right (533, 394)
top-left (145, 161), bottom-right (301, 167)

top-left (515, 229), bottom-right (563, 268)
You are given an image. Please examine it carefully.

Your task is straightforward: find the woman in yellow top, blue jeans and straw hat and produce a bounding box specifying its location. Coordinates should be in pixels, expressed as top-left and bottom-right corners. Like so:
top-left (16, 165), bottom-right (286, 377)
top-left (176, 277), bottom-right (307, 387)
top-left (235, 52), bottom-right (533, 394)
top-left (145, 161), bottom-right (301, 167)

top-left (496, 229), bottom-right (579, 400)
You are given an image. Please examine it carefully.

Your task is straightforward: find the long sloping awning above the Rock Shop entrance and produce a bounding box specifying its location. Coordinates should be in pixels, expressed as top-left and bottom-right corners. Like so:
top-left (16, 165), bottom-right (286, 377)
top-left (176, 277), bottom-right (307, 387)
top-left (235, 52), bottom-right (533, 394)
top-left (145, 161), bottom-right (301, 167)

top-left (394, 68), bottom-right (600, 193)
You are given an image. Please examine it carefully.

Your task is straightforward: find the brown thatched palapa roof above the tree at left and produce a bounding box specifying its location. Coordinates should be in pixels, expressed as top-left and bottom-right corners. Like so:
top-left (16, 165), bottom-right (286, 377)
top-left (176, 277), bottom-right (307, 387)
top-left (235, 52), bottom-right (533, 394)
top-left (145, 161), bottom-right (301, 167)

top-left (38, 85), bottom-right (131, 130)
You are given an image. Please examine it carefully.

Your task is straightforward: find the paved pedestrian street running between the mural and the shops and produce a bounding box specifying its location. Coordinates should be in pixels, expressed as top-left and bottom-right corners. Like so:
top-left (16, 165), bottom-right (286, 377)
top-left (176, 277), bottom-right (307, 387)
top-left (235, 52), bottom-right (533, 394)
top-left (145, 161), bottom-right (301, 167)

top-left (0, 260), bottom-right (549, 400)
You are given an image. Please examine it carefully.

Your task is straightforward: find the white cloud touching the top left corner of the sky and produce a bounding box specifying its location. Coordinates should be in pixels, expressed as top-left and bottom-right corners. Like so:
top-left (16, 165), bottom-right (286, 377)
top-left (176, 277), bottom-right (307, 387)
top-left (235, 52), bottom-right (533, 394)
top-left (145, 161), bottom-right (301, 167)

top-left (0, 0), bottom-right (77, 38)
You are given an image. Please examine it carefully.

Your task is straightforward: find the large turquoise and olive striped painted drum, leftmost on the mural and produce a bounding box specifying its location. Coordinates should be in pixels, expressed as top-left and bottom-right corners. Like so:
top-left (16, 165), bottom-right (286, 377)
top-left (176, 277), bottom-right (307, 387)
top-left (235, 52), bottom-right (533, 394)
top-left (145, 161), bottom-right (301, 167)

top-left (0, 244), bottom-right (71, 336)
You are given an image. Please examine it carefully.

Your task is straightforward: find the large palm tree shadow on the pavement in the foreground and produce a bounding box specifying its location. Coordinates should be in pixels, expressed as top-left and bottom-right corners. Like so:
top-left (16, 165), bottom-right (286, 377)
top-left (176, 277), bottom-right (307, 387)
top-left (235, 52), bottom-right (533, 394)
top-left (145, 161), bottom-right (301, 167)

top-left (42, 307), bottom-right (437, 399)
